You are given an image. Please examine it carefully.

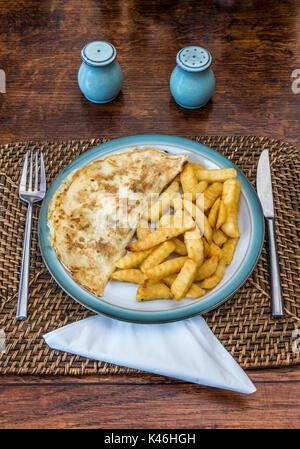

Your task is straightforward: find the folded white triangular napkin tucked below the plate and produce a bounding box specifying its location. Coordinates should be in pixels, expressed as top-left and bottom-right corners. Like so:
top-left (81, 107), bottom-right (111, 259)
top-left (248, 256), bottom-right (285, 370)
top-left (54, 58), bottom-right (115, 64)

top-left (43, 315), bottom-right (256, 394)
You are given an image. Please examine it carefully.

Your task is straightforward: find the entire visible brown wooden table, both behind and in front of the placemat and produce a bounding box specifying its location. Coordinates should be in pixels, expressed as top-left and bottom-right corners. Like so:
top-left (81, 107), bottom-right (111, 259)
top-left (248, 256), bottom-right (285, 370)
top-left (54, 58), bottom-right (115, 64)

top-left (0, 0), bottom-right (300, 429)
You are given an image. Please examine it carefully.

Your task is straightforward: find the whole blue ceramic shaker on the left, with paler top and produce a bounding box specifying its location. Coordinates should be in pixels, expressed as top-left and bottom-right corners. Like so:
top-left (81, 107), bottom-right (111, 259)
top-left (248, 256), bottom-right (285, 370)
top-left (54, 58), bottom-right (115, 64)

top-left (78, 41), bottom-right (123, 103)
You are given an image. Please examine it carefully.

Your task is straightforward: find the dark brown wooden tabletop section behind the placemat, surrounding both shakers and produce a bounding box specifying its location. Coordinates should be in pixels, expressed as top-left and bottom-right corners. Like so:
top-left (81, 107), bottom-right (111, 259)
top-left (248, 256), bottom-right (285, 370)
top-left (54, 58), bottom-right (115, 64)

top-left (0, 0), bottom-right (300, 143)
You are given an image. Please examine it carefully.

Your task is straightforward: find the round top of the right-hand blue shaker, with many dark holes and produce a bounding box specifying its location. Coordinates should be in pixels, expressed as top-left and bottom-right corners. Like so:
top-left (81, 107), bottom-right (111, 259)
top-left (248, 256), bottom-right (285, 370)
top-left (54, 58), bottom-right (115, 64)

top-left (176, 45), bottom-right (212, 72)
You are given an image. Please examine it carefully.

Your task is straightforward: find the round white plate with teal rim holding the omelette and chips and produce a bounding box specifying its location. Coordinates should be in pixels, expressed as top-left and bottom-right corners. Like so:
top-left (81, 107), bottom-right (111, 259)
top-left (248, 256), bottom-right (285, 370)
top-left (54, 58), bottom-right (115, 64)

top-left (38, 135), bottom-right (264, 323)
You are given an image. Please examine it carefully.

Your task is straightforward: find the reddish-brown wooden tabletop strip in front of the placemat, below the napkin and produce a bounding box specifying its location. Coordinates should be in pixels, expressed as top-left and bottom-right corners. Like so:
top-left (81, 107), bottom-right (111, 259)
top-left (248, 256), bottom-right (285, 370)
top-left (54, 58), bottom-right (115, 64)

top-left (0, 369), bottom-right (300, 429)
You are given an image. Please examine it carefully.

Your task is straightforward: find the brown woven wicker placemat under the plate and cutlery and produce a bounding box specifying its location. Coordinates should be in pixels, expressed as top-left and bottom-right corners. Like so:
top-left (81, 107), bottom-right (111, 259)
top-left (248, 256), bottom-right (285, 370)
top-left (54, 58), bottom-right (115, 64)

top-left (0, 136), bottom-right (300, 375)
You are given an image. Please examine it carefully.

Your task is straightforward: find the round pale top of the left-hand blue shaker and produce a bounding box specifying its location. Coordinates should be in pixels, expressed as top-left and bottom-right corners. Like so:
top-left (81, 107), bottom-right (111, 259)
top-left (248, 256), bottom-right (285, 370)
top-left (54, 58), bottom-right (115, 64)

top-left (81, 41), bottom-right (117, 67)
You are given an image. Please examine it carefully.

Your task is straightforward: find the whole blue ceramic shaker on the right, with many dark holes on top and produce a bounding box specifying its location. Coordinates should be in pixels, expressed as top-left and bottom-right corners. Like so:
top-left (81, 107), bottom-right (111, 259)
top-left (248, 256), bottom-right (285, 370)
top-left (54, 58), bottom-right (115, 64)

top-left (170, 46), bottom-right (215, 109)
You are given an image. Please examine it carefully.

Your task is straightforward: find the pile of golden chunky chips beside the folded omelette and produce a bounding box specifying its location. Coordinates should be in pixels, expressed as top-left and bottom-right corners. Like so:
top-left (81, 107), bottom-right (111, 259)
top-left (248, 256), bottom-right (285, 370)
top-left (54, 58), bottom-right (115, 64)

top-left (110, 162), bottom-right (241, 301)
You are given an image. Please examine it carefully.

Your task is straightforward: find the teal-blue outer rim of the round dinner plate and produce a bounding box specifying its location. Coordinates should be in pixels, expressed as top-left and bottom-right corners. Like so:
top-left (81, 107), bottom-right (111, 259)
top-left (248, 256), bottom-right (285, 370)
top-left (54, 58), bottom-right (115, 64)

top-left (38, 134), bottom-right (265, 323)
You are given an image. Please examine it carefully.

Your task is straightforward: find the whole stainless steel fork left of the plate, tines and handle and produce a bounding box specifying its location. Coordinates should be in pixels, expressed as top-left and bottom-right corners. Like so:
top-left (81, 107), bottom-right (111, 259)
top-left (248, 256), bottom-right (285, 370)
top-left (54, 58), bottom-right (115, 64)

top-left (16, 152), bottom-right (46, 320)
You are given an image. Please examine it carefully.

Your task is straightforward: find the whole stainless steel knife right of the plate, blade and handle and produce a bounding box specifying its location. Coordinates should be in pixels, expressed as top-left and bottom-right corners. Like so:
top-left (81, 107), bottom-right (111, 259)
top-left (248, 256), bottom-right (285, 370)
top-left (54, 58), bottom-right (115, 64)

top-left (256, 150), bottom-right (284, 316)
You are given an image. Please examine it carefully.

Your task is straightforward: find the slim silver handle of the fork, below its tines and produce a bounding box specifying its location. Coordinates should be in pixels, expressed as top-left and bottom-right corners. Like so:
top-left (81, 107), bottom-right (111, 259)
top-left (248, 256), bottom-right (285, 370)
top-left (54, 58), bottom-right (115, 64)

top-left (16, 203), bottom-right (32, 320)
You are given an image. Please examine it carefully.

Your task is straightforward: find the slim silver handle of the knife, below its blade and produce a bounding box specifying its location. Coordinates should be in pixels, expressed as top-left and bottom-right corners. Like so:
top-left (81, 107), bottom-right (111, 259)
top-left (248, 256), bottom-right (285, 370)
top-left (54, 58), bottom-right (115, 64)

top-left (266, 218), bottom-right (283, 316)
